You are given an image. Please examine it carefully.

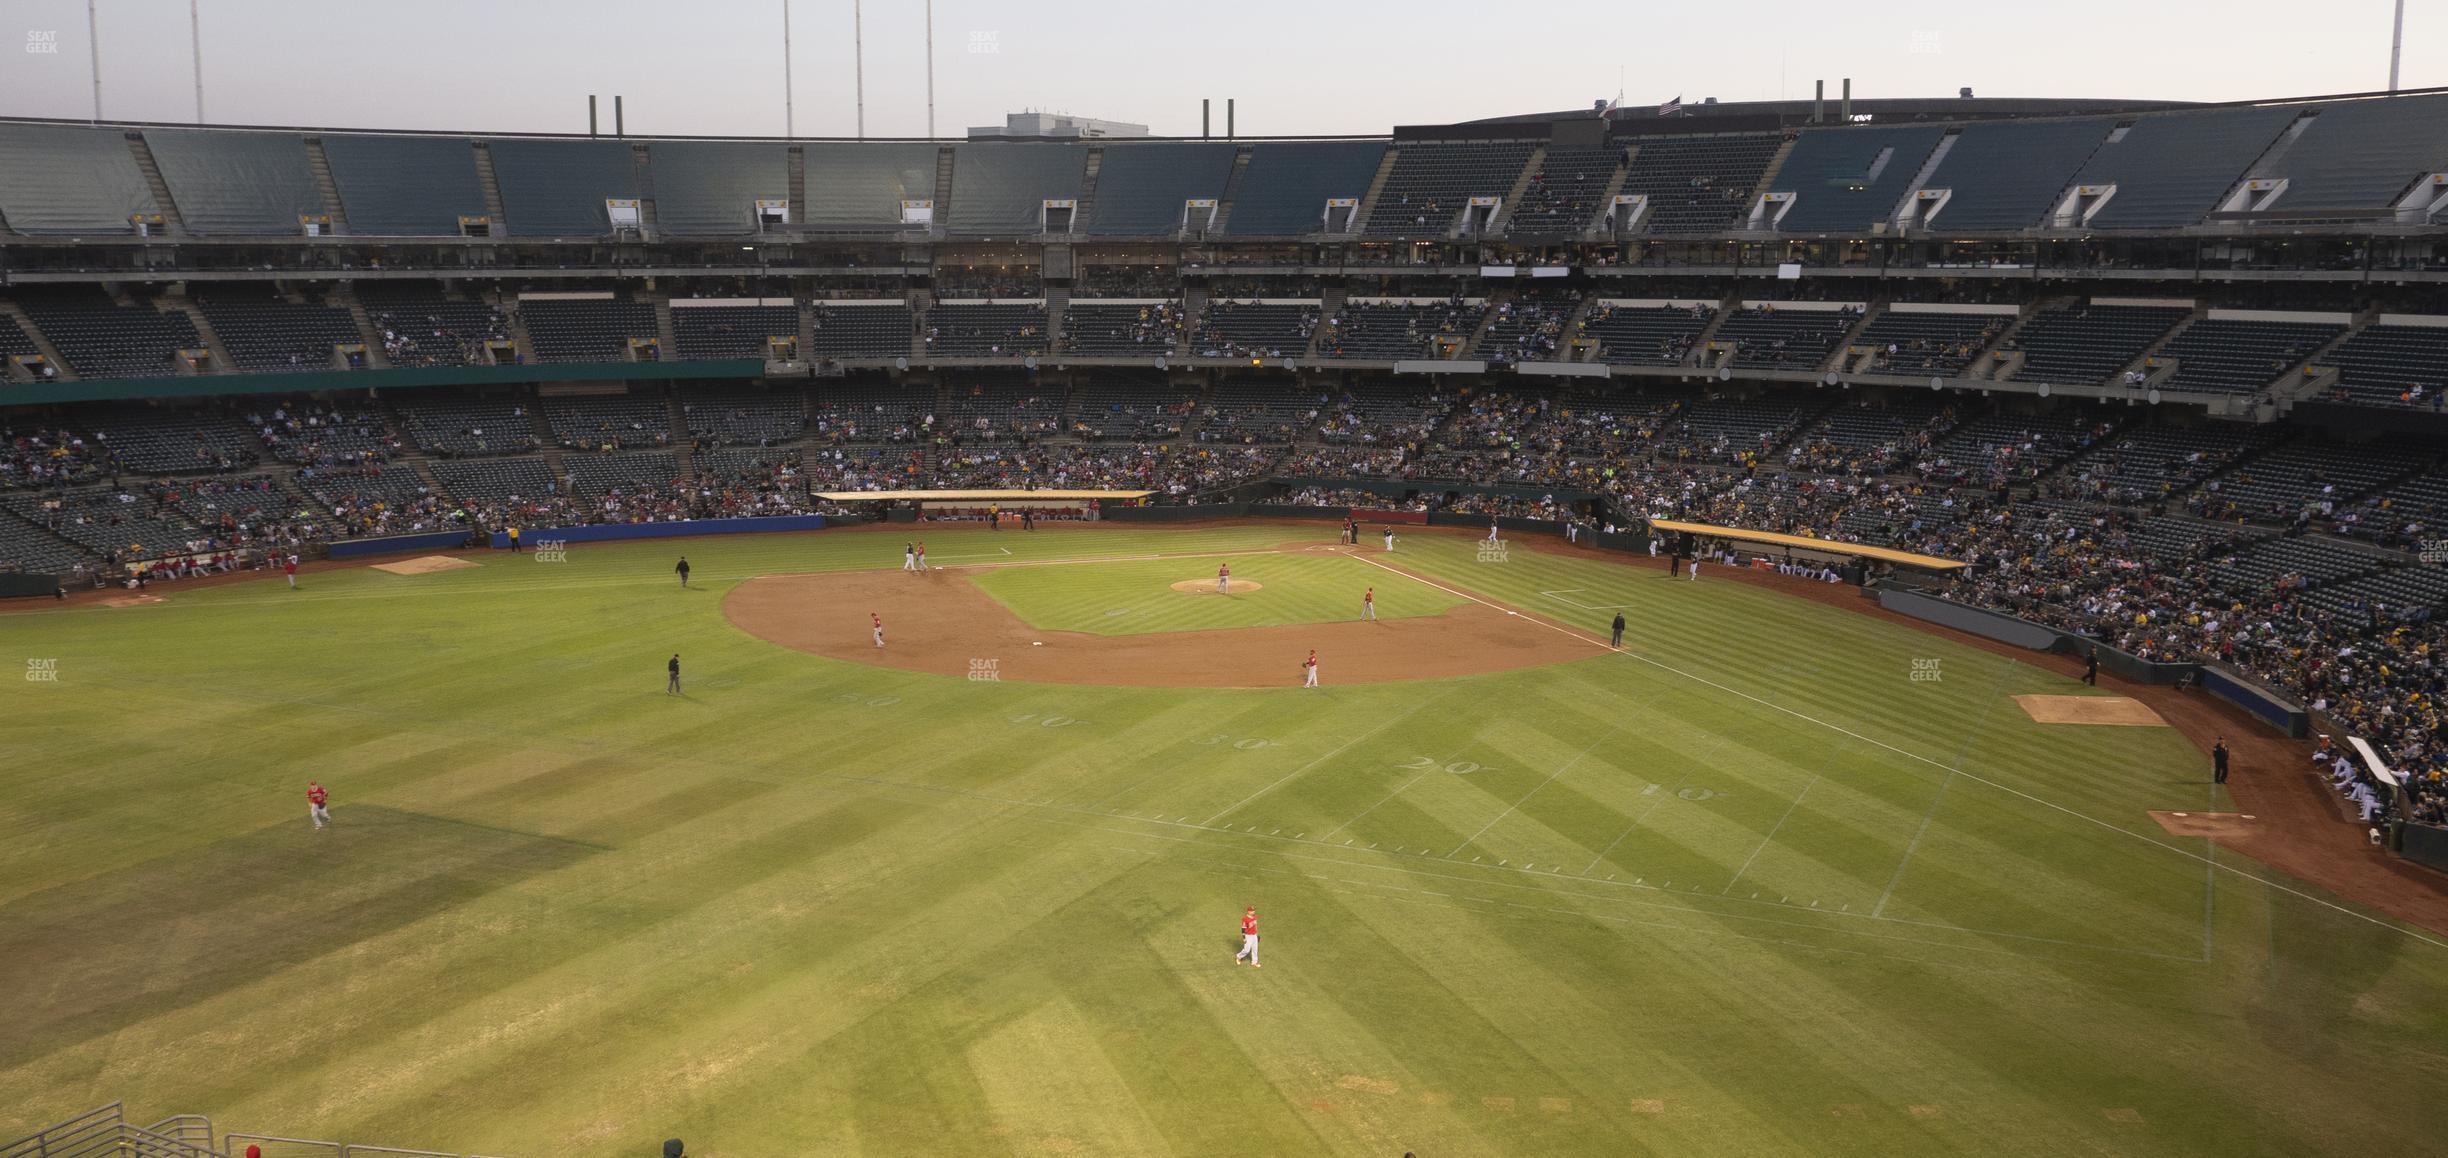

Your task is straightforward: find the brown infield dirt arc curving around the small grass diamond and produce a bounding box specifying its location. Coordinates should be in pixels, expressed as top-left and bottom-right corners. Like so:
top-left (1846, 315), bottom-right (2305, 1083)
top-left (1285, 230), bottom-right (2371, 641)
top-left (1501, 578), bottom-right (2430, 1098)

top-left (722, 553), bottom-right (1606, 688)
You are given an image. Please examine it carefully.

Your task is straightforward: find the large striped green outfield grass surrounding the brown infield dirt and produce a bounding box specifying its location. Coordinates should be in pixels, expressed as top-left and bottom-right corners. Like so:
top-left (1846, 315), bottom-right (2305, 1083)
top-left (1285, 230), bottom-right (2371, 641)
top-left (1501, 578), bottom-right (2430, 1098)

top-left (0, 526), bottom-right (2448, 1158)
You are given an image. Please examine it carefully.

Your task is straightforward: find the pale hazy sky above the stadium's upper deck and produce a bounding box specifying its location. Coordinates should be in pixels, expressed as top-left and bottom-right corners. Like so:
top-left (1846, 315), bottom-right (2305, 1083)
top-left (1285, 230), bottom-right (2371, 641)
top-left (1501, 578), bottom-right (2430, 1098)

top-left (0, 0), bottom-right (2448, 137)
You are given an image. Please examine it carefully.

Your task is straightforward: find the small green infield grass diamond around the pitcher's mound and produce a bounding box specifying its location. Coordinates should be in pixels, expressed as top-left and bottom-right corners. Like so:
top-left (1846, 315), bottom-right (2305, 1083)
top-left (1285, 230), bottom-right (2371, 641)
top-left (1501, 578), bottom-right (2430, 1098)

top-left (967, 553), bottom-right (1469, 634)
